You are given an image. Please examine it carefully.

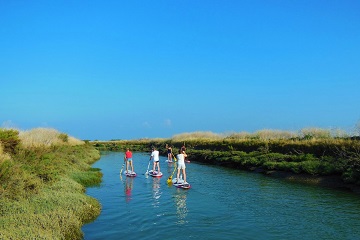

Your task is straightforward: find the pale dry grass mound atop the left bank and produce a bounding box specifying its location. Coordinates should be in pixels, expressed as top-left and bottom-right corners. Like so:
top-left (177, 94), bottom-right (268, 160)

top-left (19, 128), bottom-right (84, 147)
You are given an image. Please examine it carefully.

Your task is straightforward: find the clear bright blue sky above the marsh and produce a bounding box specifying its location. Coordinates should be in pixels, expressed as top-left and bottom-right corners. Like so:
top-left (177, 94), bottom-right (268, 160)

top-left (0, 0), bottom-right (360, 140)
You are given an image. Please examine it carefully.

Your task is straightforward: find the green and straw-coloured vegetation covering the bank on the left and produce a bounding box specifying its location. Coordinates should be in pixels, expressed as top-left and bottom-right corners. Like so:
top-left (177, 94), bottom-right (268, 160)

top-left (0, 129), bottom-right (101, 239)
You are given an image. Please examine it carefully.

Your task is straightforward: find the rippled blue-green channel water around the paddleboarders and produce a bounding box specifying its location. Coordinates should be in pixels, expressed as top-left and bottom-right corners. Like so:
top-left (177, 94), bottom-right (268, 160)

top-left (82, 152), bottom-right (360, 240)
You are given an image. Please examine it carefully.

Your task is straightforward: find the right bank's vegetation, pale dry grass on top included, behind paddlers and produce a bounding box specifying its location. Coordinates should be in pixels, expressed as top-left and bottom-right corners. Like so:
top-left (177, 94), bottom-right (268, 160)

top-left (92, 129), bottom-right (360, 185)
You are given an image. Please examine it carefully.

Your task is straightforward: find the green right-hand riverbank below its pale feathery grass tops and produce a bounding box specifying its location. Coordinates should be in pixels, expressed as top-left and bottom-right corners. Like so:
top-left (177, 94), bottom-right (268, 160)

top-left (91, 136), bottom-right (360, 192)
